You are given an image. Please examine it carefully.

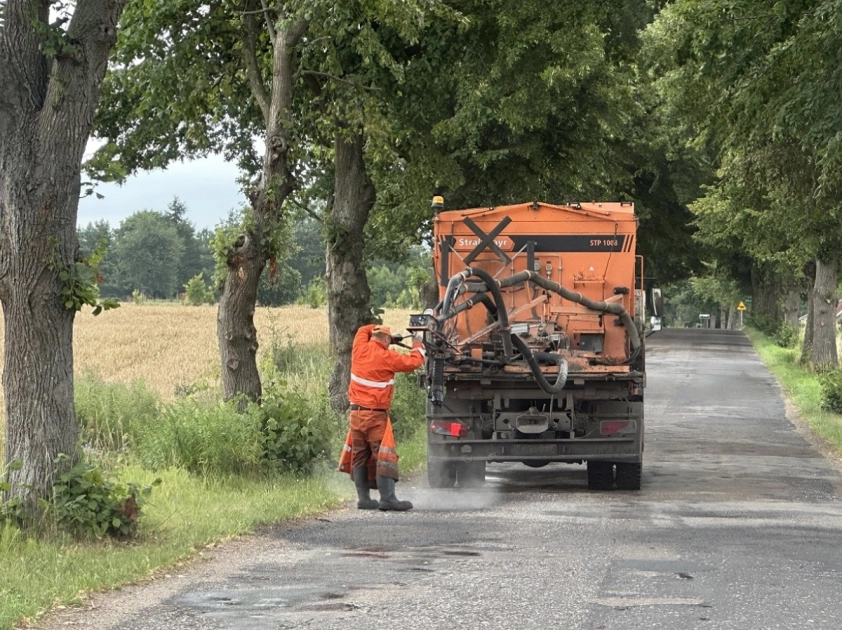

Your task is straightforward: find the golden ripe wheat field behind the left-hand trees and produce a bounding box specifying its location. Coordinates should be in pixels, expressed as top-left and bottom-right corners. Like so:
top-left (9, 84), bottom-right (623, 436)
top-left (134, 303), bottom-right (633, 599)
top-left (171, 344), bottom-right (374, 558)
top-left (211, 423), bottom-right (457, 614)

top-left (0, 303), bottom-right (409, 400)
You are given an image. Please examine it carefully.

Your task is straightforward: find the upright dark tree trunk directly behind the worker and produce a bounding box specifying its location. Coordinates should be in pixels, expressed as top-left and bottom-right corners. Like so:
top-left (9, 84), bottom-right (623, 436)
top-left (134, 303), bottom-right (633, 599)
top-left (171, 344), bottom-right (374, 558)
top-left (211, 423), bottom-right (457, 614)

top-left (326, 133), bottom-right (376, 412)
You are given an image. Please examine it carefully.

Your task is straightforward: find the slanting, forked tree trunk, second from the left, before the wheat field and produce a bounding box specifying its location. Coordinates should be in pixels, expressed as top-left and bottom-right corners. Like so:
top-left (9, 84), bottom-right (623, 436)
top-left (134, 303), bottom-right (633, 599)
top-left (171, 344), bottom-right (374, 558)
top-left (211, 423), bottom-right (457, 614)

top-left (216, 13), bottom-right (309, 407)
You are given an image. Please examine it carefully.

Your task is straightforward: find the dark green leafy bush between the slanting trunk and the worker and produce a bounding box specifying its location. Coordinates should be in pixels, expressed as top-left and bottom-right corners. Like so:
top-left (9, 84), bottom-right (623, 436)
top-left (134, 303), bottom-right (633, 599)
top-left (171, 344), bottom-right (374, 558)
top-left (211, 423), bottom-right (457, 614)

top-left (253, 382), bottom-right (334, 474)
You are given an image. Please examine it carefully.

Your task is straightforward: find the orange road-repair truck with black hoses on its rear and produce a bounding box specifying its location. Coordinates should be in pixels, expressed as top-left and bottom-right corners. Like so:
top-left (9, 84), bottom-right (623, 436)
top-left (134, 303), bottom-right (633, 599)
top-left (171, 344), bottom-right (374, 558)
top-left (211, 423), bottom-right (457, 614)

top-left (408, 197), bottom-right (646, 490)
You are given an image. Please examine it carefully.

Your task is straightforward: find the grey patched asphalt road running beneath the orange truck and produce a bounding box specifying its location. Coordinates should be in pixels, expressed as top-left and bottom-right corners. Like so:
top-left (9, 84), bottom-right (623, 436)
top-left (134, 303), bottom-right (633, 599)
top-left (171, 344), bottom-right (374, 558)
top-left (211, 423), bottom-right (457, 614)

top-left (40, 330), bottom-right (842, 630)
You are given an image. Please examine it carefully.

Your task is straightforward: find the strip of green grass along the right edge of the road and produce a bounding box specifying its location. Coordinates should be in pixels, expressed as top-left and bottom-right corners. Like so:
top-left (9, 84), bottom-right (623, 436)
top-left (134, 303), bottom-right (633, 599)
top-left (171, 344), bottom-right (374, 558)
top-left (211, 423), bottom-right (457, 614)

top-left (745, 328), bottom-right (842, 453)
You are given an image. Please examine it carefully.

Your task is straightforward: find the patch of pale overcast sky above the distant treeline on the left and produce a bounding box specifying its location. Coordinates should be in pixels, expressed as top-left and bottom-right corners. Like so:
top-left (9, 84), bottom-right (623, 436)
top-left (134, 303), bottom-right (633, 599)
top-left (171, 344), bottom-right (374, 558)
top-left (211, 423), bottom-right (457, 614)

top-left (77, 156), bottom-right (245, 230)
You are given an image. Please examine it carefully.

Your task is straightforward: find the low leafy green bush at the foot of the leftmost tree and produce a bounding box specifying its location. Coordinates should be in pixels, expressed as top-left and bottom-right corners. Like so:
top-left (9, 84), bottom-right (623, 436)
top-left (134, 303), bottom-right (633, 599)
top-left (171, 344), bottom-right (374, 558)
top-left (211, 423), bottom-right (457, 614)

top-left (53, 455), bottom-right (160, 537)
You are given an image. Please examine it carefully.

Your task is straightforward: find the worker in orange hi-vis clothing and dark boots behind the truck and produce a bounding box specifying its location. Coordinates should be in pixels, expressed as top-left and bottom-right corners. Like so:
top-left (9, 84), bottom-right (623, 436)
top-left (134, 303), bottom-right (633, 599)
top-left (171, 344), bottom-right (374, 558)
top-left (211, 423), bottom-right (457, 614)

top-left (348, 324), bottom-right (424, 511)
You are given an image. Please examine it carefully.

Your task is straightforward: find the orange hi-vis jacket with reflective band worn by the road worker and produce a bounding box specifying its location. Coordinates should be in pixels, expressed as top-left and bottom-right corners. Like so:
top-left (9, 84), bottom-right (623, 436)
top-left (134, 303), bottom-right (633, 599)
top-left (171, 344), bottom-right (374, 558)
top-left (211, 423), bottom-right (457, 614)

top-left (348, 324), bottom-right (424, 411)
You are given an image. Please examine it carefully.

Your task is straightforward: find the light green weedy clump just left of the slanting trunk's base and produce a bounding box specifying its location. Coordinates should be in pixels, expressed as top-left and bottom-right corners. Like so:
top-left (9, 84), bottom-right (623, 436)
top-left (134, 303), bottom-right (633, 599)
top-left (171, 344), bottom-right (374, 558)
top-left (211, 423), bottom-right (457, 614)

top-left (134, 398), bottom-right (261, 475)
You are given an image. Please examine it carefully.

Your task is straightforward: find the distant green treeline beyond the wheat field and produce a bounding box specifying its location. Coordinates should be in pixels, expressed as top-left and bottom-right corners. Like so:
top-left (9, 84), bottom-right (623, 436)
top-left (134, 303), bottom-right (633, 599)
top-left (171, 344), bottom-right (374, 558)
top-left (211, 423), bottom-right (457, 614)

top-left (78, 197), bottom-right (430, 308)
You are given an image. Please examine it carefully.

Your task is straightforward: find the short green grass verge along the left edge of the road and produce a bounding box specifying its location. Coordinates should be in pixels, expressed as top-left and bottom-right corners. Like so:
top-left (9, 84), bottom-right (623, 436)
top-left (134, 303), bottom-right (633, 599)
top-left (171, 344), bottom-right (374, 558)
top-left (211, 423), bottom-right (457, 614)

top-left (0, 414), bottom-right (427, 630)
